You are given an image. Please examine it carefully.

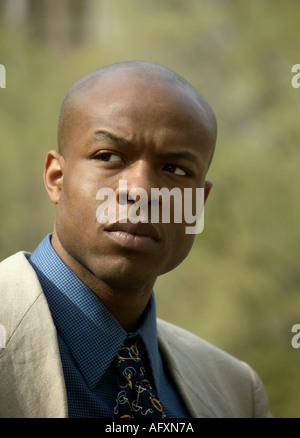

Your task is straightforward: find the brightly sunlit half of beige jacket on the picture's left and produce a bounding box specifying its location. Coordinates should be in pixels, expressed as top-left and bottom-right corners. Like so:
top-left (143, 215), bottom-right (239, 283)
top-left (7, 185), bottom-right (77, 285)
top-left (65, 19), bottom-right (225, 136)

top-left (0, 252), bottom-right (67, 418)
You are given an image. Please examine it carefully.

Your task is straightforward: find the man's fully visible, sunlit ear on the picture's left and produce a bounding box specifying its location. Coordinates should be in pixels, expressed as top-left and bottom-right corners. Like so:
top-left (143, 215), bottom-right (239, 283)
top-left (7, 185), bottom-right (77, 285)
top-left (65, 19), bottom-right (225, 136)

top-left (44, 150), bottom-right (65, 204)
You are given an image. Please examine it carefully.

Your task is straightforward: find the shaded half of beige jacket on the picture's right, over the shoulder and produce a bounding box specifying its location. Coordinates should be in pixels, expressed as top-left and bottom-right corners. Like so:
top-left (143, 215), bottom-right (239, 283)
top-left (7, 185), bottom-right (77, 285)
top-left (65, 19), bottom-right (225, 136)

top-left (157, 319), bottom-right (271, 417)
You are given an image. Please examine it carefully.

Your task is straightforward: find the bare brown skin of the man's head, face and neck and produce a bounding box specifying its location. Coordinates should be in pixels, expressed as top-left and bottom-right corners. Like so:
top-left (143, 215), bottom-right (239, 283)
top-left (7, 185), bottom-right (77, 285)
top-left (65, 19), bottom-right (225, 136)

top-left (44, 66), bottom-right (216, 331)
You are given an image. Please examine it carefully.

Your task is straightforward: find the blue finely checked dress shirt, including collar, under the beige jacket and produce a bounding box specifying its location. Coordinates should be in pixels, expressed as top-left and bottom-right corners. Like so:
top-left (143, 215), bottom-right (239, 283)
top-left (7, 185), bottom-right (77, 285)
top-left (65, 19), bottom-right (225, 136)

top-left (29, 234), bottom-right (188, 418)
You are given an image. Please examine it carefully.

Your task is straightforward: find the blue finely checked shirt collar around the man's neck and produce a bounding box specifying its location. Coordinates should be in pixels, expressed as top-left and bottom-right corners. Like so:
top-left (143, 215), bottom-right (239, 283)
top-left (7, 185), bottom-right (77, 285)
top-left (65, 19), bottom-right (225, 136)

top-left (29, 234), bottom-right (160, 389)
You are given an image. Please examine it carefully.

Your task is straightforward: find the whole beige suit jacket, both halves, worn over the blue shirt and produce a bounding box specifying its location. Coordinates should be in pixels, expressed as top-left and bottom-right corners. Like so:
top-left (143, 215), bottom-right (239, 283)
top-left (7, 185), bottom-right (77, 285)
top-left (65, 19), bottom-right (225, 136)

top-left (0, 252), bottom-right (271, 418)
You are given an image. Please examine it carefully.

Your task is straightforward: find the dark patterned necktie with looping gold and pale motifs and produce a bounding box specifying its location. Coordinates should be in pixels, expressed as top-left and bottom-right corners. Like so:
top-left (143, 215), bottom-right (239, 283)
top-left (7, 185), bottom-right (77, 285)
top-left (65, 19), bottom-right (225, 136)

top-left (114, 339), bottom-right (166, 418)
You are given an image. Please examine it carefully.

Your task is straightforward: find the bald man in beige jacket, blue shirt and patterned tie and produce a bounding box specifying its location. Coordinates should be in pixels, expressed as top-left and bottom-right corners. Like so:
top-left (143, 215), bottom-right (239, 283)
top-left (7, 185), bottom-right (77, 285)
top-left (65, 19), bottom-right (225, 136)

top-left (0, 62), bottom-right (270, 418)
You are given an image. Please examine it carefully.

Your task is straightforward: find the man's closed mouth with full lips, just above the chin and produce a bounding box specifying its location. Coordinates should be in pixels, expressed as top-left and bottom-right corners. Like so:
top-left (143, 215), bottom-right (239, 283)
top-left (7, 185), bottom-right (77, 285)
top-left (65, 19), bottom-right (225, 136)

top-left (104, 222), bottom-right (161, 251)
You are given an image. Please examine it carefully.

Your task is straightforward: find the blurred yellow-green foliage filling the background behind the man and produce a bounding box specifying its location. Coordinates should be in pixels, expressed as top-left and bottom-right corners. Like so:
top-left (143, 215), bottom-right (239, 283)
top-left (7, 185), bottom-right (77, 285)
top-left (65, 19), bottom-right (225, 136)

top-left (0, 0), bottom-right (300, 417)
